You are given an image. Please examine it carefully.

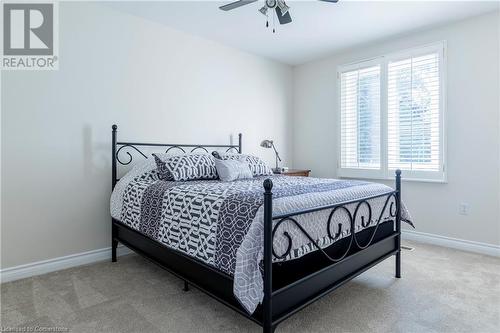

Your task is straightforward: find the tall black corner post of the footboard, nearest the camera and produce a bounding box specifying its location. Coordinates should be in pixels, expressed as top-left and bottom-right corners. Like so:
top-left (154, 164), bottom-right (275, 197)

top-left (262, 178), bottom-right (274, 333)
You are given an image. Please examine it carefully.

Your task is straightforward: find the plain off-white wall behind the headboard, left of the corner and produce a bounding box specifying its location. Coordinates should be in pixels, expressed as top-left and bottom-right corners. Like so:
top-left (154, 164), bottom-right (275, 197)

top-left (1, 3), bottom-right (292, 268)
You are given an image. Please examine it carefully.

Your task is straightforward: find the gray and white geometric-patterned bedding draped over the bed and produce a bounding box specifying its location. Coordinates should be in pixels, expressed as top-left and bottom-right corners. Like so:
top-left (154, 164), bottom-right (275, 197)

top-left (111, 161), bottom-right (410, 313)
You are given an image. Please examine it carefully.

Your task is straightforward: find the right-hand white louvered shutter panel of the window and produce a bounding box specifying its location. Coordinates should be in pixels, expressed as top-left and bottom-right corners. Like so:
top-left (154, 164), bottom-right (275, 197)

top-left (387, 51), bottom-right (442, 172)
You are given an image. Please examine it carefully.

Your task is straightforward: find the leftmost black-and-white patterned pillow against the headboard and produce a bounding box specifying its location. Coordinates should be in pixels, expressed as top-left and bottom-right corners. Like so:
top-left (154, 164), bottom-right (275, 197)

top-left (153, 154), bottom-right (217, 181)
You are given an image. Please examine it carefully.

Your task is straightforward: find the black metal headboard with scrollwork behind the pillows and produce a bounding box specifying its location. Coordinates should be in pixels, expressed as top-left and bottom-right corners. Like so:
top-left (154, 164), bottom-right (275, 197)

top-left (111, 125), bottom-right (242, 189)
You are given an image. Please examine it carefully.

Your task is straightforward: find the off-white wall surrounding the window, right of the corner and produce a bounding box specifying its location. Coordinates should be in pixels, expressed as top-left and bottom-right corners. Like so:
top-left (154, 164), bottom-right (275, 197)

top-left (293, 12), bottom-right (500, 245)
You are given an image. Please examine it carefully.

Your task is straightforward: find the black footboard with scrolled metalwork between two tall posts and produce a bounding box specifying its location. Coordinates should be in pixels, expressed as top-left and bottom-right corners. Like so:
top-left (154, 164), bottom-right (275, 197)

top-left (262, 170), bottom-right (401, 332)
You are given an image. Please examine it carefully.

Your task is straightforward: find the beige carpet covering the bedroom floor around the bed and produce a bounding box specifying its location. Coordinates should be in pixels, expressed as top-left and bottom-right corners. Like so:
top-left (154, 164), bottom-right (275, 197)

top-left (1, 242), bottom-right (500, 332)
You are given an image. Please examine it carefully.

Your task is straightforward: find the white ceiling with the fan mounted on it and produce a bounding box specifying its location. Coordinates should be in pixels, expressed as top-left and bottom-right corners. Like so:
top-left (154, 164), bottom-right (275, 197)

top-left (103, 0), bottom-right (499, 65)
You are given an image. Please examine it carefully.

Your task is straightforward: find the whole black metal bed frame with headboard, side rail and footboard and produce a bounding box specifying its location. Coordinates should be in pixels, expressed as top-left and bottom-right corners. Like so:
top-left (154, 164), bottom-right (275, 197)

top-left (112, 125), bottom-right (401, 333)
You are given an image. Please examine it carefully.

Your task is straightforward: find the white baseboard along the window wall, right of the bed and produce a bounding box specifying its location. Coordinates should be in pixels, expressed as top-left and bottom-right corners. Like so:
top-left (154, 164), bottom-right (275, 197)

top-left (401, 230), bottom-right (500, 257)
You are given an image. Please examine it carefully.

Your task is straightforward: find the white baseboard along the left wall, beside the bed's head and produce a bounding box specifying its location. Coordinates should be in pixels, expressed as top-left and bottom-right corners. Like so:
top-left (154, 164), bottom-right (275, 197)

top-left (0, 245), bottom-right (132, 283)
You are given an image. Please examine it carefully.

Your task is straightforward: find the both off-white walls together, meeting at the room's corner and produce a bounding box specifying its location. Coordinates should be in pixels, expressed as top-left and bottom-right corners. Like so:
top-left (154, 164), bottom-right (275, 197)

top-left (0, 3), bottom-right (500, 268)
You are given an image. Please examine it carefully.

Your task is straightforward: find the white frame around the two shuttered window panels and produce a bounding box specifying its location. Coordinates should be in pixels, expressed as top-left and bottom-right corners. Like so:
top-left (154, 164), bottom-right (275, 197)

top-left (336, 41), bottom-right (448, 183)
